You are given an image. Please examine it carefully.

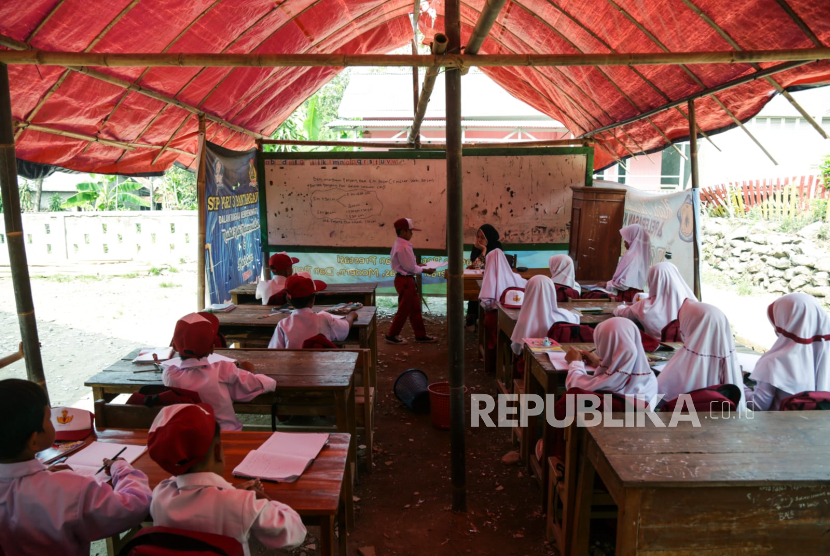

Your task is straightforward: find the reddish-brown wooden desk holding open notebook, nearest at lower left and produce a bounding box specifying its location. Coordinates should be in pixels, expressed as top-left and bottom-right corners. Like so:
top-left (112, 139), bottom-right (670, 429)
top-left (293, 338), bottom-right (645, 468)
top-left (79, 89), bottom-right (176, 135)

top-left (98, 429), bottom-right (354, 556)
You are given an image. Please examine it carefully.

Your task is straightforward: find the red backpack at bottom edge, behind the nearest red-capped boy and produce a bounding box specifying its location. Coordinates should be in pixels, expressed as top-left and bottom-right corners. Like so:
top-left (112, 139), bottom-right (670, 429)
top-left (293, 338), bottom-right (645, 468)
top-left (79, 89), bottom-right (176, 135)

top-left (118, 527), bottom-right (245, 556)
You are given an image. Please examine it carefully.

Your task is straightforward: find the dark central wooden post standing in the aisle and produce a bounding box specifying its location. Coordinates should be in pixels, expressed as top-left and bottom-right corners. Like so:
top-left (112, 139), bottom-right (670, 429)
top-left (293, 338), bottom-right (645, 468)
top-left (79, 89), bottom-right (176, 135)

top-left (446, 0), bottom-right (467, 512)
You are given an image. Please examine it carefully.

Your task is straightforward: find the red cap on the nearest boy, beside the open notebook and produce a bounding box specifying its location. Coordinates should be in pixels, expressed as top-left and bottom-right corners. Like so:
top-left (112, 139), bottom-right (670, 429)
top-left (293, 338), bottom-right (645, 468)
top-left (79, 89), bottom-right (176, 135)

top-left (147, 403), bottom-right (216, 475)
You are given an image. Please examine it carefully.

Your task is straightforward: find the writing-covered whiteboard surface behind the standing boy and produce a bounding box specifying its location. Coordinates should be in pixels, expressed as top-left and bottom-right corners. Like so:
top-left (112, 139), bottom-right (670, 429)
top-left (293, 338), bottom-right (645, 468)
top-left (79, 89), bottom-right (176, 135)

top-left (260, 148), bottom-right (593, 250)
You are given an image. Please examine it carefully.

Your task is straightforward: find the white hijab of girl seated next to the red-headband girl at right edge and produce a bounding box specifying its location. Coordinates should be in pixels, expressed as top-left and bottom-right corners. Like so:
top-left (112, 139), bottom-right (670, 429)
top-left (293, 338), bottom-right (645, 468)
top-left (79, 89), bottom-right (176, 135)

top-left (657, 298), bottom-right (746, 409)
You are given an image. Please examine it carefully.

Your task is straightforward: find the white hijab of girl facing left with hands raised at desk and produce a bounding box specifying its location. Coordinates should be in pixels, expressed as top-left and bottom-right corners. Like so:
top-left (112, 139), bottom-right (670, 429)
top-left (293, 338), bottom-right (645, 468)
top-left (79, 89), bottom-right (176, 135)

top-left (594, 317), bottom-right (657, 403)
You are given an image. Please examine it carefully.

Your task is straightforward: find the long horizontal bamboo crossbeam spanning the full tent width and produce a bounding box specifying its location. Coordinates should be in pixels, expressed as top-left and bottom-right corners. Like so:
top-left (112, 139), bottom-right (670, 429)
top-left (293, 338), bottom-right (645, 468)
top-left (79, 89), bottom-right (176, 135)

top-left (0, 48), bottom-right (830, 69)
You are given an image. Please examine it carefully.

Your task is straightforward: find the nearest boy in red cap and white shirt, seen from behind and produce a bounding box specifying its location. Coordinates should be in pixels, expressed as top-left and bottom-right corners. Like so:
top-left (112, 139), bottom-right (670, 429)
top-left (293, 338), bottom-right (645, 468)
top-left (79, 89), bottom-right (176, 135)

top-left (147, 404), bottom-right (306, 556)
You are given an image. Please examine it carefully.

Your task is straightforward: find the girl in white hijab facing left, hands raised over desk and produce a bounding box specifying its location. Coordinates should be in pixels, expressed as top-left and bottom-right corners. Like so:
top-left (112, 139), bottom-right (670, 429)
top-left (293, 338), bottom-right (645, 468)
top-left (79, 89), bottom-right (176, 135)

top-left (565, 317), bottom-right (657, 403)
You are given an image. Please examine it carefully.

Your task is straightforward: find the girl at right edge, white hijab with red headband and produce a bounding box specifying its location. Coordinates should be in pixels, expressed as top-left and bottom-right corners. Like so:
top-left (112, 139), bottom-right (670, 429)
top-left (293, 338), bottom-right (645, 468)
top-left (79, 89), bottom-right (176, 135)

top-left (750, 293), bottom-right (830, 411)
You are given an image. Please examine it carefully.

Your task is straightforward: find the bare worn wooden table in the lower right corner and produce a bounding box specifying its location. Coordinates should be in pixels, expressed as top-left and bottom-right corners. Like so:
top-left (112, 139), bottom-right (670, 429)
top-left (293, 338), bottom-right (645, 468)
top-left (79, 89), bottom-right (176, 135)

top-left (572, 411), bottom-right (830, 556)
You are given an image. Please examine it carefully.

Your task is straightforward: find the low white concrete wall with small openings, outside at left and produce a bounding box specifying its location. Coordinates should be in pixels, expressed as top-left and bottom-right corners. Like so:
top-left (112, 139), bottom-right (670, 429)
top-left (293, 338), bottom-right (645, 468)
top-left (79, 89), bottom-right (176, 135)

top-left (0, 211), bottom-right (198, 265)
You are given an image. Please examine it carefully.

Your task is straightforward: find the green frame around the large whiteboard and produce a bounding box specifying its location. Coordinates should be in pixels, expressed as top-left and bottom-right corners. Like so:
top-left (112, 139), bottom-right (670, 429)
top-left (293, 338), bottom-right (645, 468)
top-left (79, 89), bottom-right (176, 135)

top-left (256, 147), bottom-right (594, 255)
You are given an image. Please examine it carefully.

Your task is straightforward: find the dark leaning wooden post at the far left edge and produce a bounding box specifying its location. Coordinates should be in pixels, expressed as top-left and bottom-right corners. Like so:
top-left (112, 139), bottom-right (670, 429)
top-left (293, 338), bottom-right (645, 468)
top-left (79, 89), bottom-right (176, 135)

top-left (0, 64), bottom-right (48, 395)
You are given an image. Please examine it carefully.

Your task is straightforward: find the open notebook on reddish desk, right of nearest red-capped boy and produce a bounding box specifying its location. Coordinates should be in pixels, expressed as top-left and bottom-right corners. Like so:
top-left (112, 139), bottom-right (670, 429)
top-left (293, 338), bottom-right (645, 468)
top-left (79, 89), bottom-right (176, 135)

top-left (233, 432), bottom-right (329, 483)
